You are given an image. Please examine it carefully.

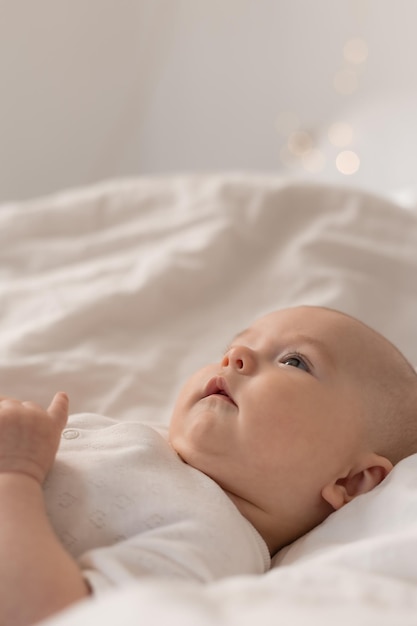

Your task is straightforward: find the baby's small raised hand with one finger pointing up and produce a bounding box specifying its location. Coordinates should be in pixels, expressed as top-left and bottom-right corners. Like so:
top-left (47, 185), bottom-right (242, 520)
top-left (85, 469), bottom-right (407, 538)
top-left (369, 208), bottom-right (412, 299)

top-left (0, 392), bottom-right (68, 484)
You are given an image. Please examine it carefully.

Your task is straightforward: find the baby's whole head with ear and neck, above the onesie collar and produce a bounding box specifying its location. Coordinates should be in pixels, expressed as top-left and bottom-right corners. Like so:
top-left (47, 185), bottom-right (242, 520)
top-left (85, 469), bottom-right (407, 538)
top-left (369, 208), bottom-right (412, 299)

top-left (170, 307), bottom-right (417, 553)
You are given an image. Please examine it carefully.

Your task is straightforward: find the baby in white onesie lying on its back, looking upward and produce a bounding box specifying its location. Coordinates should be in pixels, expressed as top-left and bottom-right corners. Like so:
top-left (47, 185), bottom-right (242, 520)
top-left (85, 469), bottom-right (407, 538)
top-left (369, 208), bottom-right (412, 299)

top-left (0, 307), bottom-right (417, 626)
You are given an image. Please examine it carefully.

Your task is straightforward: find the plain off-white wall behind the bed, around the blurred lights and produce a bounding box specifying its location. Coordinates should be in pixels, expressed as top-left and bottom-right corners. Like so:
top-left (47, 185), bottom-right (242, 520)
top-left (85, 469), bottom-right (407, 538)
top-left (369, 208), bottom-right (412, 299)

top-left (0, 0), bottom-right (417, 201)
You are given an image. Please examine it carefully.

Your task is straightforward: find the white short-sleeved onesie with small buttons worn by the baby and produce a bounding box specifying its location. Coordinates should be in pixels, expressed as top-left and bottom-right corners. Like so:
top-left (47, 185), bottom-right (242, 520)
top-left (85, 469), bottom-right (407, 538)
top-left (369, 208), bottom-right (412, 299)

top-left (44, 413), bottom-right (270, 592)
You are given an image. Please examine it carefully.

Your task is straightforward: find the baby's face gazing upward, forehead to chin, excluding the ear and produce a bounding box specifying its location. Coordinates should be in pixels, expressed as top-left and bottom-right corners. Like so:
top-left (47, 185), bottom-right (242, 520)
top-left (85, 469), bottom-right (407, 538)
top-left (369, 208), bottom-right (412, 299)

top-left (170, 307), bottom-right (380, 544)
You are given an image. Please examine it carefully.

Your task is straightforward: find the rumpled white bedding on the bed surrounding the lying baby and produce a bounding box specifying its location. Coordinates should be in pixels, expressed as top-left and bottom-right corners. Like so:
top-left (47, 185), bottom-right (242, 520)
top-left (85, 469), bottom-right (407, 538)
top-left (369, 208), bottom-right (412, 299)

top-left (0, 173), bottom-right (417, 626)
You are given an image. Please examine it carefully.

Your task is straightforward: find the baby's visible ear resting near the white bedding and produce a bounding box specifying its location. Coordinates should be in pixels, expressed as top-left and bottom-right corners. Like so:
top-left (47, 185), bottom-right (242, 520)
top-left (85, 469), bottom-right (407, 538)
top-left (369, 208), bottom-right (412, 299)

top-left (321, 453), bottom-right (393, 510)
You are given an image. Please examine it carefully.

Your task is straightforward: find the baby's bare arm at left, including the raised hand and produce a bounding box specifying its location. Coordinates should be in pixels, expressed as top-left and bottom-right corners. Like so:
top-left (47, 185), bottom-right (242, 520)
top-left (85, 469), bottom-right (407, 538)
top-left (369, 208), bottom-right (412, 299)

top-left (0, 393), bottom-right (89, 626)
